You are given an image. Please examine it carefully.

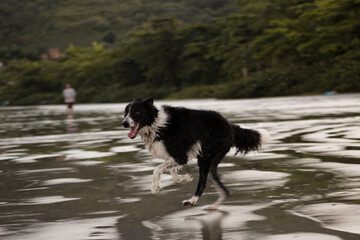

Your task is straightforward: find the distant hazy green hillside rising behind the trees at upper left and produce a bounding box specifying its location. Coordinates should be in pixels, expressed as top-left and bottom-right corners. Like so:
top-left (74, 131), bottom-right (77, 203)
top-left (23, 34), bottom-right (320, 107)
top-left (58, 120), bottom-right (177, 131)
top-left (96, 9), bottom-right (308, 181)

top-left (0, 0), bottom-right (234, 57)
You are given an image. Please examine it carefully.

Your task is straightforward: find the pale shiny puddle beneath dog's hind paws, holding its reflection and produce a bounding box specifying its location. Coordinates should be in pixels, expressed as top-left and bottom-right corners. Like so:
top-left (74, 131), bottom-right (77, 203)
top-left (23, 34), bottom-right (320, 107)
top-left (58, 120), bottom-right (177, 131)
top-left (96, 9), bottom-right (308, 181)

top-left (142, 204), bottom-right (268, 240)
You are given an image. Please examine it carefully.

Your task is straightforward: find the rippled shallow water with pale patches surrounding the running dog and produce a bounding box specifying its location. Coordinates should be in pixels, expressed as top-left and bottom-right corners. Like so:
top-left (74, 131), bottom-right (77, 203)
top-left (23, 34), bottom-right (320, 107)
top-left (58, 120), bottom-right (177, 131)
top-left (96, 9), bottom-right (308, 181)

top-left (0, 94), bottom-right (360, 240)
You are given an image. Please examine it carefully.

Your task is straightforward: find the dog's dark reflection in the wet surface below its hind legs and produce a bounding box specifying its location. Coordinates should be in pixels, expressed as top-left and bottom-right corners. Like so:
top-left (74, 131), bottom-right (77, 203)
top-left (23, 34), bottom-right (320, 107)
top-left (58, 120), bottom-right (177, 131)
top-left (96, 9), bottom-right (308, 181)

top-left (185, 211), bottom-right (229, 240)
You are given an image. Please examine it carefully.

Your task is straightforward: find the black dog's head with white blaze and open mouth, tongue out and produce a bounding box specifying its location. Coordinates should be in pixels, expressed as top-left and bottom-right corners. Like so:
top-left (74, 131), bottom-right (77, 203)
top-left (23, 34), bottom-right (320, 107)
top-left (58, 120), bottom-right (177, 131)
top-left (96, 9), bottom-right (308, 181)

top-left (122, 97), bottom-right (157, 139)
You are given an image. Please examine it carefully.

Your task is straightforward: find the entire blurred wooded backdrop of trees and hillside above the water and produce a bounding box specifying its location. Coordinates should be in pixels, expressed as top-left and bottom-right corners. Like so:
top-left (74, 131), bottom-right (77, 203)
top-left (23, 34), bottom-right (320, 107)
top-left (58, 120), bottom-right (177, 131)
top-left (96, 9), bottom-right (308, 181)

top-left (0, 0), bottom-right (360, 105)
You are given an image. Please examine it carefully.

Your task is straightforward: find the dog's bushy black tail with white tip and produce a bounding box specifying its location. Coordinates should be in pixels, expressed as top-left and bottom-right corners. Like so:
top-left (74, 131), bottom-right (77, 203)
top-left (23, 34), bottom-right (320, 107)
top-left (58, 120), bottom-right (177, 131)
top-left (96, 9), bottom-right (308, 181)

top-left (231, 124), bottom-right (270, 155)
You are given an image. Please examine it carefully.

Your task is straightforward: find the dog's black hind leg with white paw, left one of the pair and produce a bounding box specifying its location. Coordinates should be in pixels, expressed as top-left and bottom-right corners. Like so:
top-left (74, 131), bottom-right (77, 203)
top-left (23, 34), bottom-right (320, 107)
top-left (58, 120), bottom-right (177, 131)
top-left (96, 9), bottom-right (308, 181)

top-left (182, 156), bottom-right (210, 207)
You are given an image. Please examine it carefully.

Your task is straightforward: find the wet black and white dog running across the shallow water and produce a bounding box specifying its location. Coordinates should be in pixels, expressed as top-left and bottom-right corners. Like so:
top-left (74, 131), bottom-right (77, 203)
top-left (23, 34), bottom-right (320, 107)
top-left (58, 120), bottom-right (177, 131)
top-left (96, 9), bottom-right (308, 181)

top-left (122, 98), bottom-right (270, 209)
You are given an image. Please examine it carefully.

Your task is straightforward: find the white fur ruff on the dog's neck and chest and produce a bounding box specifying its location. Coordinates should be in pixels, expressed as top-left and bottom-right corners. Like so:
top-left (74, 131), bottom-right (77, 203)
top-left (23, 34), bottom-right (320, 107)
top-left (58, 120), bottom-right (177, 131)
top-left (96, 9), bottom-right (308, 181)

top-left (138, 107), bottom-right (170, 160)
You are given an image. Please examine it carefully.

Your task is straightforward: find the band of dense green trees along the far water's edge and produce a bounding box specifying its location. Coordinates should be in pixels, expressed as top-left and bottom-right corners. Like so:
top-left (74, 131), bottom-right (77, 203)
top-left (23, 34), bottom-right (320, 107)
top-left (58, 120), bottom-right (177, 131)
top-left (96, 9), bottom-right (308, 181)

top-left (0, 0), bottom-right (360, 104)
